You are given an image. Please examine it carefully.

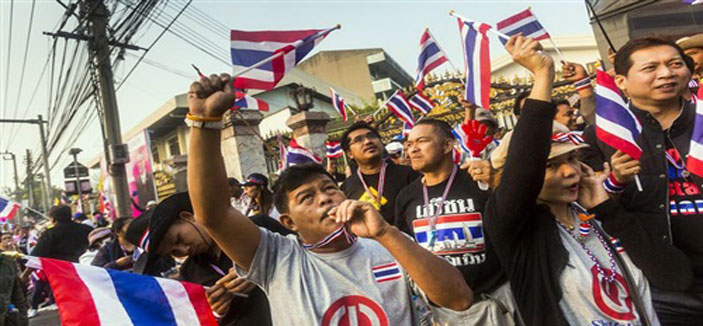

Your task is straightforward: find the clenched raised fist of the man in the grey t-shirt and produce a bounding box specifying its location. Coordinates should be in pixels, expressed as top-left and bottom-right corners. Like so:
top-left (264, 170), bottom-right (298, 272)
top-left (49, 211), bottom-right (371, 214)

top-left (188, 74), bottom-right (235, 118)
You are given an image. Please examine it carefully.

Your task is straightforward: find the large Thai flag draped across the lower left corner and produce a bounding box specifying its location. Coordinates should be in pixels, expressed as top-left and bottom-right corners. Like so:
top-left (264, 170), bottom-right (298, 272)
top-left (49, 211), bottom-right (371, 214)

top-left (27, 257), bottom-right (217, 326)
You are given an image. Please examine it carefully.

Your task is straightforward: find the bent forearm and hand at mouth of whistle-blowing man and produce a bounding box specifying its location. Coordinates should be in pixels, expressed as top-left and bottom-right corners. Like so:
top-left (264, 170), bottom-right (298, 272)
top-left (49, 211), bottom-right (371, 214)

top-left (330, 200), bottom-right (473, 311)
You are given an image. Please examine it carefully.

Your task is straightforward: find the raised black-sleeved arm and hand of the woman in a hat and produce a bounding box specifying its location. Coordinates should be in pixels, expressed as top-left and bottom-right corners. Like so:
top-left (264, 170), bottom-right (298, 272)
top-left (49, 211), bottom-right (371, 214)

top-left (486, 36), bottom-right (556, 256)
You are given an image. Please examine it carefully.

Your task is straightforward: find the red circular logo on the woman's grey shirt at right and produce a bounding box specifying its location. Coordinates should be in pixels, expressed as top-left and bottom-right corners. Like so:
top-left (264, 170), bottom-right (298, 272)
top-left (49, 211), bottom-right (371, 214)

top-left (591, 265), bottom-right (636, 321)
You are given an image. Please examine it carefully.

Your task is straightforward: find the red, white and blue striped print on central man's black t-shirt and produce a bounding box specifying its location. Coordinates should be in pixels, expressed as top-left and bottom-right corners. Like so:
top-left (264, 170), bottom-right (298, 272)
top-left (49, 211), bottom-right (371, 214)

top-left (413, 213), bottom-right (485, 255)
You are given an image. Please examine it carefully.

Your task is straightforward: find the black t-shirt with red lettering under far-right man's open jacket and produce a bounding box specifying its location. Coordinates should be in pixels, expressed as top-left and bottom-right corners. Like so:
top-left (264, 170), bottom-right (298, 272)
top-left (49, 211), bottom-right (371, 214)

top-left (666, 140), bottom-right (703, 291)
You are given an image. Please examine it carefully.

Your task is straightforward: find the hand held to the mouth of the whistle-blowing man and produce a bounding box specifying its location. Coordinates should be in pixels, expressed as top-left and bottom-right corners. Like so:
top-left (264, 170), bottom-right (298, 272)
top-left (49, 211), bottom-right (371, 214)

top-left (329, 199), bottom-right (390, 239)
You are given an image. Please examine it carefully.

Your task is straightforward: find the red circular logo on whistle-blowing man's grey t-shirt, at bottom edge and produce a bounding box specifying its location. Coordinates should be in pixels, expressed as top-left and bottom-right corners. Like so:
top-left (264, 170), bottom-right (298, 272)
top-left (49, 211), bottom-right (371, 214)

top-left (322, 295), bottom-right (389, 326)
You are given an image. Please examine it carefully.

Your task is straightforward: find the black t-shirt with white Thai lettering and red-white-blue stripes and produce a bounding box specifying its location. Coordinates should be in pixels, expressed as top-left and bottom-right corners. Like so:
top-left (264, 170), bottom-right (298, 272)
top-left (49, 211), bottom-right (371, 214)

top-left (395, 170), bottom-right (505, 293)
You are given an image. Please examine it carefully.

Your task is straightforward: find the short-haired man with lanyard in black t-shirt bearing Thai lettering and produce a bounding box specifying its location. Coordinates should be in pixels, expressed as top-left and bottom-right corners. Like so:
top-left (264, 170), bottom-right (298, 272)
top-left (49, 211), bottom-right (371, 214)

top-left (395, 119), bottom-right (512, 320)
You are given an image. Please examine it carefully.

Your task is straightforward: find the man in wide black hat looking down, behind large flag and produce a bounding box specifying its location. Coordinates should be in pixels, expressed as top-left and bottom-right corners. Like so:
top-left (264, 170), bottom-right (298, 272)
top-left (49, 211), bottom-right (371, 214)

top-left (127, 192), bottom-right (283, 325)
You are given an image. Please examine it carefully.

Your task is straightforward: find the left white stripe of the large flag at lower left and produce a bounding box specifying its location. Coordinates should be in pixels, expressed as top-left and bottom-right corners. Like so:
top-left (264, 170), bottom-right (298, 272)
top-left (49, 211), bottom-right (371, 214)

top-left (73, 264), bottom-right (133, 326)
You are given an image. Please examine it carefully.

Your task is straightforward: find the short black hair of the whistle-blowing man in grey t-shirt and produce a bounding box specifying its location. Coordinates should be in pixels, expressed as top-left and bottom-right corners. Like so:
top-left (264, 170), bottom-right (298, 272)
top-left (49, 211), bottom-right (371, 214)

top-left (273, 163), bottom-right (334, 214)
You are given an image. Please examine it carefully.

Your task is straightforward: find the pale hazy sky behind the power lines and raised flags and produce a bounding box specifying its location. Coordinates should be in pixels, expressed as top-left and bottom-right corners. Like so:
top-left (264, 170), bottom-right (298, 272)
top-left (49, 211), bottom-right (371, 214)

top-left (0, 0), bottom-right (592, 196)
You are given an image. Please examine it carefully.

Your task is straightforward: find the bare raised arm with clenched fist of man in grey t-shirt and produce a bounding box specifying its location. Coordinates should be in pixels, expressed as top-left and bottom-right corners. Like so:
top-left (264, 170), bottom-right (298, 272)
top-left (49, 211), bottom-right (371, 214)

top-left (188, 74), bottom-right (261, 270)
